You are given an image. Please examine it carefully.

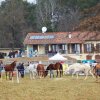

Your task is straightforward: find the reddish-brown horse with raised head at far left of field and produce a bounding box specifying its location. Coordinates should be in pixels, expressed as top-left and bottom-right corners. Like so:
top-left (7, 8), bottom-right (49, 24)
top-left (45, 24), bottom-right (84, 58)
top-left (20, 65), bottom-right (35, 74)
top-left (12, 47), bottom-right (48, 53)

top-left (4, 61), bottom-right (16, 80)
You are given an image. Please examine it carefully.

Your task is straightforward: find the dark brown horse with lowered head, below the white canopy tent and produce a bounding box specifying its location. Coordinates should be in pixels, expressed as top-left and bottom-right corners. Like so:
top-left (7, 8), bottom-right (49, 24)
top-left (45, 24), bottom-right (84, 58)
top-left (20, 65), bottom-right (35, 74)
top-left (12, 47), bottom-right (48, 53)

top-left (46, 62), bottom-right (63, 78)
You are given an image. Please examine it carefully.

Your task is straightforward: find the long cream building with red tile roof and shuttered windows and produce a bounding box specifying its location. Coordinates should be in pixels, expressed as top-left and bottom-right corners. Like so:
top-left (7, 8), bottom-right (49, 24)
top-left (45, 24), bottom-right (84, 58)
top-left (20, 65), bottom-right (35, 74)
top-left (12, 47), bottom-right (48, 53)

top-left (24, 32), bottom-right (100, 60)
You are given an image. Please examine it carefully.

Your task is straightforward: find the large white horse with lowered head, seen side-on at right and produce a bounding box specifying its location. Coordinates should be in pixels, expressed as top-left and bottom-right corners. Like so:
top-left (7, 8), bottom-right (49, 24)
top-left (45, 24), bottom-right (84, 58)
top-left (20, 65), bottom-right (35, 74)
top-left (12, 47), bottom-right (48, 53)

top-left (65, 63), bottom-right (94, 80)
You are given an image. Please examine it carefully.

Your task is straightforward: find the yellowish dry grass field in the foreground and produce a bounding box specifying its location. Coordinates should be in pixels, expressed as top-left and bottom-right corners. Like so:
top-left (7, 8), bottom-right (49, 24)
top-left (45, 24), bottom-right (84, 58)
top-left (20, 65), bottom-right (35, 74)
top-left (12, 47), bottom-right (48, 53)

top-left (0, 75), bottom-right (100, 100)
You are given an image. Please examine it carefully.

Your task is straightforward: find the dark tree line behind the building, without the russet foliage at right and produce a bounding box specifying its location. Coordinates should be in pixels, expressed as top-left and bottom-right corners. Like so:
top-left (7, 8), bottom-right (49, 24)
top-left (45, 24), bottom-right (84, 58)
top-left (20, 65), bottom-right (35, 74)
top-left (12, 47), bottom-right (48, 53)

top-left (0, 0), bottom-right (100, 48)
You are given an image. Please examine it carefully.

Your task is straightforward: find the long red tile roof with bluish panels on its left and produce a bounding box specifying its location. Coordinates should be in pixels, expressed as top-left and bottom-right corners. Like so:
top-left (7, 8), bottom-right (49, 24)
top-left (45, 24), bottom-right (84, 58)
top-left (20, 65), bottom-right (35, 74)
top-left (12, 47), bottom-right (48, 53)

top-left (24, 32), bottom-right (100, 44)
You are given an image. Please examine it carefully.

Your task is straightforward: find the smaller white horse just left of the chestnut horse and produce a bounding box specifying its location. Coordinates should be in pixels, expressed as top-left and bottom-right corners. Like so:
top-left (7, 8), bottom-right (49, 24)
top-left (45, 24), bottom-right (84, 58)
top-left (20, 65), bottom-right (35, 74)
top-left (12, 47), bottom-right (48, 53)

top-left (27, 63), bottom-right (38, 80)
